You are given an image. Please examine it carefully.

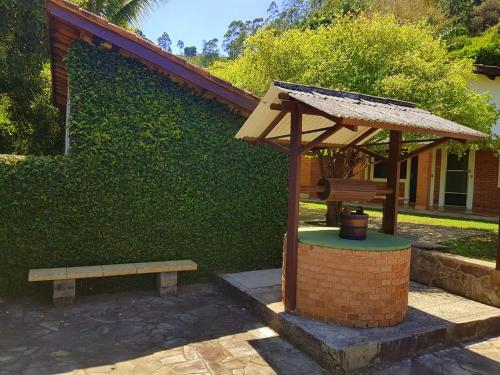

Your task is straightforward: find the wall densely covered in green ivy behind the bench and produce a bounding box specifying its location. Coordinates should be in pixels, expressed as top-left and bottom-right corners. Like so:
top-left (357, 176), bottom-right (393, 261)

top-left (0, 42), bottom-right (287, 295)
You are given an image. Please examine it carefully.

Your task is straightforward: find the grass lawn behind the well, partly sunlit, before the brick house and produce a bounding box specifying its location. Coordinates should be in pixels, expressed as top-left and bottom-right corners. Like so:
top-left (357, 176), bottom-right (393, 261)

top-left (300, 202), bottom-right (498, 262)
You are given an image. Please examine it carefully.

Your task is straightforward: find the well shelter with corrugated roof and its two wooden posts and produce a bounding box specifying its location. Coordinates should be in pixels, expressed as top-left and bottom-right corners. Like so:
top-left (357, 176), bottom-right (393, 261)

top-left (236, 81), bottom-right (486, 318)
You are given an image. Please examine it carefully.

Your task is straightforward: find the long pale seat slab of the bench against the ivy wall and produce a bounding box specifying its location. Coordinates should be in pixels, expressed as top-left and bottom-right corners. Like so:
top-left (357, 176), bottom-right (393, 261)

top-left (28, 260), bottom-right (198, 281)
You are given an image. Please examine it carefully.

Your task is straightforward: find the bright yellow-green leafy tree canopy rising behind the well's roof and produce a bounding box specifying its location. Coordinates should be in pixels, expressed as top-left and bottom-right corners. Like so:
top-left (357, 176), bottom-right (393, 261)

top-left (210, 15), bottom-right (497, 145)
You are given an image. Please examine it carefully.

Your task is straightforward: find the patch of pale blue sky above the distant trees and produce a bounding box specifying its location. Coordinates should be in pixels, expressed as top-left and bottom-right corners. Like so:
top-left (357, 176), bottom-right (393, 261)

top-left (139, 0), bottom-right (278, 53)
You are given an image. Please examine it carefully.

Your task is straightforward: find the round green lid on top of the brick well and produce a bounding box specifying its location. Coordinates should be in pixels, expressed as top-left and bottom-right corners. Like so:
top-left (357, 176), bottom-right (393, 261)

top-left (299, 227), bottom-right (411, 251)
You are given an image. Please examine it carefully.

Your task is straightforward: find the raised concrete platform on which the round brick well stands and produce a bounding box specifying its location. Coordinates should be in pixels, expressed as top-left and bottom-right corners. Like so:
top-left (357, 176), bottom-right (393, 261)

top-left (218, 269), bottom-right (500, 371)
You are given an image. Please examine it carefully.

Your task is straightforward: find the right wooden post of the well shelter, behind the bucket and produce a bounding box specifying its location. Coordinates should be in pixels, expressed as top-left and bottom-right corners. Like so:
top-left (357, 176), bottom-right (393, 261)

top-left (382, 130), bottom-right (402, 234)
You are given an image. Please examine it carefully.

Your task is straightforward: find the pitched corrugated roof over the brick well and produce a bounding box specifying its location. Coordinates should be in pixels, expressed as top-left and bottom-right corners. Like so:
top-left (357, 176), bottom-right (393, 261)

top-left (236, 81), bottom-right (486, 146)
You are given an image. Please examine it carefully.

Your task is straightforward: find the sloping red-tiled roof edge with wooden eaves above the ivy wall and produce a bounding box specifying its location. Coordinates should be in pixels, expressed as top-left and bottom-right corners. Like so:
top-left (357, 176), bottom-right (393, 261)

top-left (45, 0), bottom-right (259, 114)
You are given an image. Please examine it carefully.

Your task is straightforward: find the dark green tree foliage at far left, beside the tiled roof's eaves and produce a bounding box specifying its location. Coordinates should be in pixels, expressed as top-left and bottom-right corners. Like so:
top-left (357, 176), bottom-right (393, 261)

top-left (0, 0), bottom-right (63, 154)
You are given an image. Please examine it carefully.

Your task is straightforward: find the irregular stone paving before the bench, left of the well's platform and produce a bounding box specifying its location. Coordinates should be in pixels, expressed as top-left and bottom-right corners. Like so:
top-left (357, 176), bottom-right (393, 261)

top-left (0, 284), bottom-right (325, 375)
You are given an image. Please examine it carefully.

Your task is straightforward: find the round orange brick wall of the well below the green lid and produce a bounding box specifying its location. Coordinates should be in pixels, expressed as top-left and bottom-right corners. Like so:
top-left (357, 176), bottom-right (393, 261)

top-left (284, 239), bottom-right (411, 327)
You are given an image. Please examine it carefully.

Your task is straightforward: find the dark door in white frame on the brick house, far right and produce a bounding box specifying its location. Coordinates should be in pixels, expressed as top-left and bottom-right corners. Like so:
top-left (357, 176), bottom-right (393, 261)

top-left (444, 152), bottom-right (469, 207)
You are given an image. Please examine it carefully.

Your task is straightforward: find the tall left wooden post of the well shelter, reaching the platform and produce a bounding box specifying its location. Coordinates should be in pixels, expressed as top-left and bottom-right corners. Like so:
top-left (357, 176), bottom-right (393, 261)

top-left (283, 106), bottom-right (302, 310)
